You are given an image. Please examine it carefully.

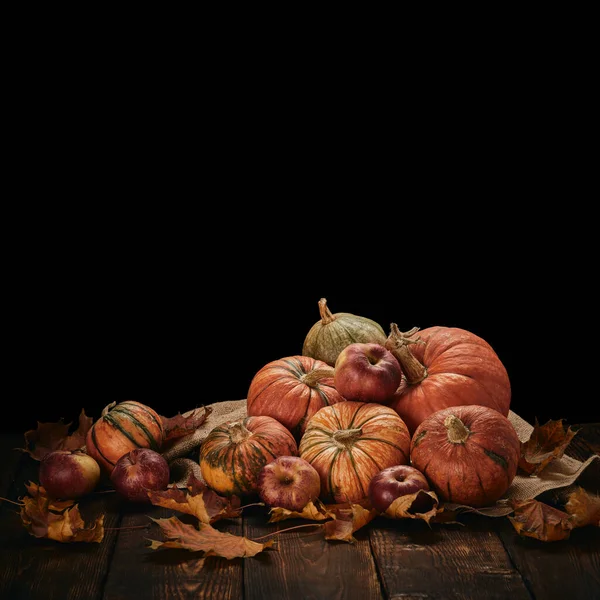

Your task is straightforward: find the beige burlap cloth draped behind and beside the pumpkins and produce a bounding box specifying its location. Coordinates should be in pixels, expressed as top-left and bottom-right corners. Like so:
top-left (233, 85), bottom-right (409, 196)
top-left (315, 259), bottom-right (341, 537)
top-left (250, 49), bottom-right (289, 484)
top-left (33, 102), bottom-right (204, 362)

top-left (167, 398), bottom-right (600, 517)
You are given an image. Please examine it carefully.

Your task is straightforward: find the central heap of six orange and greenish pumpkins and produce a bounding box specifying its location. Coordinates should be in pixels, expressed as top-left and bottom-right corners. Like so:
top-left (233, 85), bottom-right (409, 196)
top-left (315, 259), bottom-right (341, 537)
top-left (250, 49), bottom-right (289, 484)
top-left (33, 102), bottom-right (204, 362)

top-left (88, 298), bottom-right (520, 507)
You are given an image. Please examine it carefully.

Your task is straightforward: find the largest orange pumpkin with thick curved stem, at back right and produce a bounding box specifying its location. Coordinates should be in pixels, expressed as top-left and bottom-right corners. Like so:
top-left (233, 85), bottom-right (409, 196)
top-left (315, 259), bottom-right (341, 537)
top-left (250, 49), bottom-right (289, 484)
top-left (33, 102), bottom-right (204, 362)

top-left (385, 323), bottom-right (511, 435)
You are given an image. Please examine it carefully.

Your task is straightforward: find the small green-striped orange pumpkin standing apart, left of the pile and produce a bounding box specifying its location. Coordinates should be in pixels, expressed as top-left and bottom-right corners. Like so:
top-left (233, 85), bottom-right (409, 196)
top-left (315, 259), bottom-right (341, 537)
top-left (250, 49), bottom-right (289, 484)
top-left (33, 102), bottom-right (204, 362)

top-left (85, 400), bottom-right (165, 474)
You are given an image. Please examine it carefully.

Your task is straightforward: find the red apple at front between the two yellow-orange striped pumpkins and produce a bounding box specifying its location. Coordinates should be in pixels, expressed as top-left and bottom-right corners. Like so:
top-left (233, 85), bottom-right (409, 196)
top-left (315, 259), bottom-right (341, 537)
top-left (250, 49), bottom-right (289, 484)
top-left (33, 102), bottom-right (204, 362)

top-left (258, 456), bottom-right (321, 512)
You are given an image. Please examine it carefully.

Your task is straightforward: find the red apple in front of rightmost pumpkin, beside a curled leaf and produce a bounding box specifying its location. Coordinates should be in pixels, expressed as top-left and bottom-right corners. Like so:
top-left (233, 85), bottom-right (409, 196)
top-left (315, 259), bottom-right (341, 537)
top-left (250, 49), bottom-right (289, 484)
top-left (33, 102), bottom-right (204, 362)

top-left (369, 465), bottom-right (429, 512)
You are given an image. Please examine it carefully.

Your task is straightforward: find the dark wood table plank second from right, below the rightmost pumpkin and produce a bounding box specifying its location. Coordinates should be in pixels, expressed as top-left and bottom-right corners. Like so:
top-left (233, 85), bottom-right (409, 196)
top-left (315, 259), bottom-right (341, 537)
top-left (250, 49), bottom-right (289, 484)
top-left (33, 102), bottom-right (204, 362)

top-left (369, 515), bottom-right (531, 600)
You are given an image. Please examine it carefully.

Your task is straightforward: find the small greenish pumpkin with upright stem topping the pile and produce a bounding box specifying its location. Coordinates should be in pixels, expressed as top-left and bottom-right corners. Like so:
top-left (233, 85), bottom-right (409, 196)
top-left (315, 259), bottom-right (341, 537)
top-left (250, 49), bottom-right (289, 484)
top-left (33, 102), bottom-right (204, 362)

top-left (302, 298), bottom-right (387, 367)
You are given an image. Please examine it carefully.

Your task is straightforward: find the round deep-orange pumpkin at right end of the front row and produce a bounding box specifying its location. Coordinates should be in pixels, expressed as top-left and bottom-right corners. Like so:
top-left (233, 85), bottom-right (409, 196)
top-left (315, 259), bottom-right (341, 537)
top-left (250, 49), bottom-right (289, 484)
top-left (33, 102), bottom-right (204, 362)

top-left (410, 404), bottom-right (521, 507)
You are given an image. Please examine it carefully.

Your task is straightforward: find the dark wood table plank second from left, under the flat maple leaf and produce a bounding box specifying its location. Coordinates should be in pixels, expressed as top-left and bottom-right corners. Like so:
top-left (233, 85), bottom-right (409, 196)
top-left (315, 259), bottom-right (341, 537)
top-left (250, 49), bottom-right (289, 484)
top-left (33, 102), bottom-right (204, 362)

top-left (103, 502), bottom-right (243, 600)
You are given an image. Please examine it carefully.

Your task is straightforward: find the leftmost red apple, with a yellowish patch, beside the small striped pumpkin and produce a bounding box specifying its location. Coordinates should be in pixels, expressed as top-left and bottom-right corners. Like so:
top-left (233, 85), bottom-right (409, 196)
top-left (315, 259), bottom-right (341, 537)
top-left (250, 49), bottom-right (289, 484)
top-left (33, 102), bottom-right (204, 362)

top-left (39, 450), bottom-right (100, 500)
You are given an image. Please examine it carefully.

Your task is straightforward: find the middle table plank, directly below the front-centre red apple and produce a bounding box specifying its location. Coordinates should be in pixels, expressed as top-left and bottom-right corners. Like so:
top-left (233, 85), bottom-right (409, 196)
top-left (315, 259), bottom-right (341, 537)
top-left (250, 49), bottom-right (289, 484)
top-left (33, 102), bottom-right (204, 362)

top-left (244, 508), bottom-right (382, 600)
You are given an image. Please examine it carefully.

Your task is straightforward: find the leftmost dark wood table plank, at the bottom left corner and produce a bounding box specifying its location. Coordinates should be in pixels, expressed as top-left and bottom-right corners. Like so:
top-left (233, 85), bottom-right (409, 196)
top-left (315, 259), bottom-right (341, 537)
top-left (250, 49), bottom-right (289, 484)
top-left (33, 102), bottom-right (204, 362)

top-left (0, 448), bottom-right (120, 600)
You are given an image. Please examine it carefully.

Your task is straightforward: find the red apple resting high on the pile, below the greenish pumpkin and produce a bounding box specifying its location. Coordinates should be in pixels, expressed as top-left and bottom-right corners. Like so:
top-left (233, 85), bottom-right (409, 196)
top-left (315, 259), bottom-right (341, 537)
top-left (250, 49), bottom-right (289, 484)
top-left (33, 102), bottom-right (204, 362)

top-left (333, 343), bottom-right (402, 404)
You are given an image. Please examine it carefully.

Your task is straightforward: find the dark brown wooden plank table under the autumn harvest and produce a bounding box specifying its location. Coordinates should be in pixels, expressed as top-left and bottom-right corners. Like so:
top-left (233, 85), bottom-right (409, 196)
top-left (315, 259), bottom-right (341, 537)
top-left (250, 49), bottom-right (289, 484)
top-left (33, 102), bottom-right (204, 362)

top-left (0, 424), bottom-right (600, 600)
